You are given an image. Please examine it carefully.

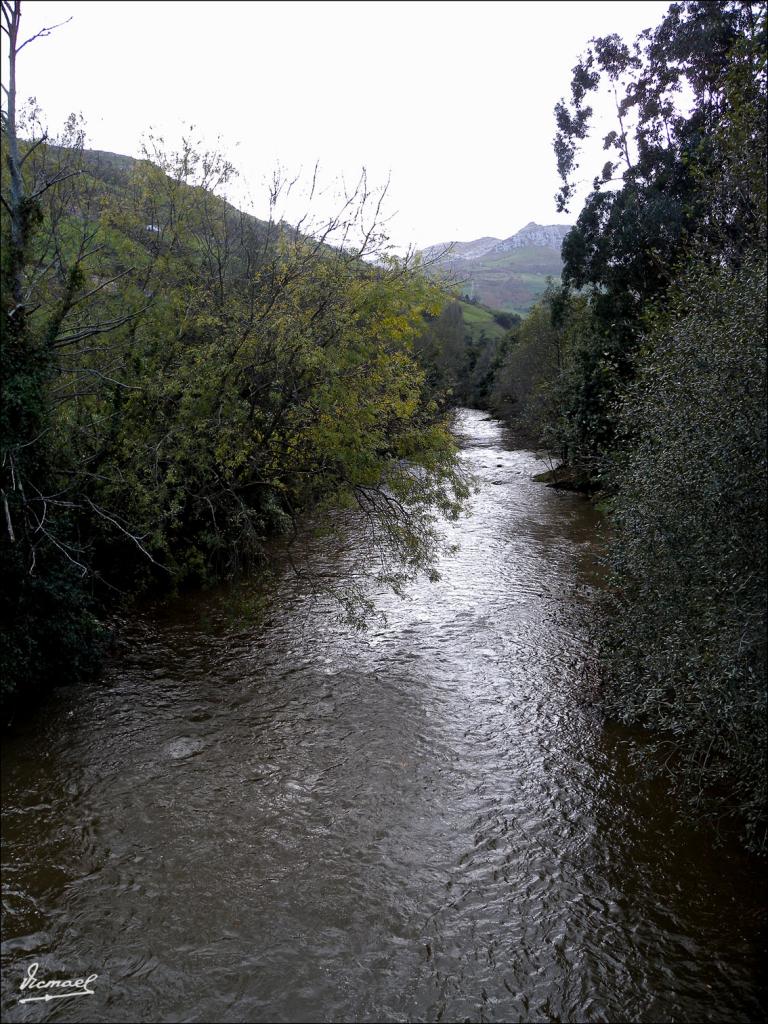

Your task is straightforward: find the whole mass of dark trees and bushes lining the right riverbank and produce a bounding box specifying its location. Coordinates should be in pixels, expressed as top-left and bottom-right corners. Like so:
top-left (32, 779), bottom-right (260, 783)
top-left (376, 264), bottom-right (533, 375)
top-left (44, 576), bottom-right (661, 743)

top-left (483, 2), bottom-right (768, 847)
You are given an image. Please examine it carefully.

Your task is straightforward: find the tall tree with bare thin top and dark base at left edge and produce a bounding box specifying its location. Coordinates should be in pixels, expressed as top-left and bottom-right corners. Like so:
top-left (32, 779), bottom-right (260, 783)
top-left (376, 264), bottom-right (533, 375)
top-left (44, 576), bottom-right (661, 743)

top-left (0, 0), bottom-right (147, 686)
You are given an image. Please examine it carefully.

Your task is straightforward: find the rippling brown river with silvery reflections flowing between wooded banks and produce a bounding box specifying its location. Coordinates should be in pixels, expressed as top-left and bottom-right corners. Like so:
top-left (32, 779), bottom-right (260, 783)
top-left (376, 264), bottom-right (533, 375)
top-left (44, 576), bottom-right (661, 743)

top-left (3, 411), bottom-right (765, 1022)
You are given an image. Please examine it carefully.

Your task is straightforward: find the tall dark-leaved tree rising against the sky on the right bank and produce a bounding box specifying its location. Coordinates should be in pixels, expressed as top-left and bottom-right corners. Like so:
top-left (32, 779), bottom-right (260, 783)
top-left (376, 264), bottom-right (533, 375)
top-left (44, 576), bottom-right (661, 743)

top-left (555, 0), bottom-right (765, 481)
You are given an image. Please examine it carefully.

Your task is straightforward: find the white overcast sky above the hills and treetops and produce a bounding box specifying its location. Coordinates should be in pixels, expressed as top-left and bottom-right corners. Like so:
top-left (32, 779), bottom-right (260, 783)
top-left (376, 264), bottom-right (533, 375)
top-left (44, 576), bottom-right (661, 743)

top-left (4, 0), bottom-right (669, 247)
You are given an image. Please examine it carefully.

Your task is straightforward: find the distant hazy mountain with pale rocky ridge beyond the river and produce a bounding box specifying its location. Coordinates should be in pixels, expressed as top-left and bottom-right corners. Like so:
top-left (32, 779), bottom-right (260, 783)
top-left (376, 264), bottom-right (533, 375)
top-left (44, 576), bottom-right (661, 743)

top-left (422, 221), bottom-right (570, 313)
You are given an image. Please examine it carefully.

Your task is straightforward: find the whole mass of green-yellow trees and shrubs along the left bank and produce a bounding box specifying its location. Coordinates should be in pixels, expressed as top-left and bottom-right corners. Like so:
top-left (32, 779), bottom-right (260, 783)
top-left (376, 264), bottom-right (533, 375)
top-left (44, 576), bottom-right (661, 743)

top-left (0, 3), bottom-right (467, 704)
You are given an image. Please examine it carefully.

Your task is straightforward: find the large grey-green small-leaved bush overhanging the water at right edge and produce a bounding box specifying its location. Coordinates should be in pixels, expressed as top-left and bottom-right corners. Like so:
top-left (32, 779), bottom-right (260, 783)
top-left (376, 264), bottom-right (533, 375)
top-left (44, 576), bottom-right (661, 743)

top-left (606, 252), bottom-right (768, 845)
